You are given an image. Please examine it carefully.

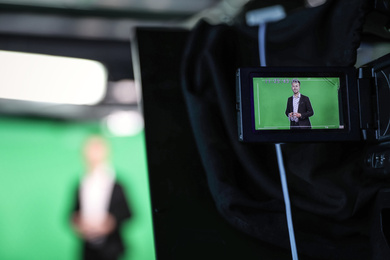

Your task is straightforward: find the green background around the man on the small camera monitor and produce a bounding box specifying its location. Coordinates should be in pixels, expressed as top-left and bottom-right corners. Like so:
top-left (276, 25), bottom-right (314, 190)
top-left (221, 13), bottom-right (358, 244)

top-left (253, 78), bottom-right (340, 130)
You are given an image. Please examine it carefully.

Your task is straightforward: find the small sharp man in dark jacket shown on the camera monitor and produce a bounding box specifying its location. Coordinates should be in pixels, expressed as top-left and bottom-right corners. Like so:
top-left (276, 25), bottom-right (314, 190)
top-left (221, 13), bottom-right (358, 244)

top-left (286, 79), bottom-right (314, 129)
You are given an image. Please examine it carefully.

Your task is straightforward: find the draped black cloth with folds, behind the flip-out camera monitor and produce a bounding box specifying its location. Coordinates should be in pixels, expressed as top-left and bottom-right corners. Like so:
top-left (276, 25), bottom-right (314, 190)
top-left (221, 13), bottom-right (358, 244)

top-left (182, 0), bottom-right (388, 260)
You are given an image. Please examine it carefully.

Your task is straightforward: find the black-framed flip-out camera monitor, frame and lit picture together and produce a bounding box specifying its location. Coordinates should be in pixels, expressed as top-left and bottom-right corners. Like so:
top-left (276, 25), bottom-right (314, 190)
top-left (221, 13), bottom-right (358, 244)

top-left (237, 67), bottom-right (360, 142)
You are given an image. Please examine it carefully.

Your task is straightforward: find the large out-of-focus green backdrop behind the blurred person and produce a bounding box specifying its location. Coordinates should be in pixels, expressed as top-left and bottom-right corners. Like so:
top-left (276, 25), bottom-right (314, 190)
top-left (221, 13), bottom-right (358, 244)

top-left (0, 118), bottom-right (155, 260)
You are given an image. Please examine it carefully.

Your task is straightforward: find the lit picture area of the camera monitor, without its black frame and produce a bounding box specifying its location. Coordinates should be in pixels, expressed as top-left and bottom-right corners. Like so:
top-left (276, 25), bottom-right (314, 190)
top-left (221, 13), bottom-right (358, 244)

top-left (253, 76), bottom-right (344, 130)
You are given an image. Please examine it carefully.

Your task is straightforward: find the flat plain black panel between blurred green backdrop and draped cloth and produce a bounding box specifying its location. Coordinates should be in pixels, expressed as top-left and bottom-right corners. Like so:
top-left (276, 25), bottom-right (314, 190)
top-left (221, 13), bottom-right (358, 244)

top-left (136, 28), bottom-right (298, 260)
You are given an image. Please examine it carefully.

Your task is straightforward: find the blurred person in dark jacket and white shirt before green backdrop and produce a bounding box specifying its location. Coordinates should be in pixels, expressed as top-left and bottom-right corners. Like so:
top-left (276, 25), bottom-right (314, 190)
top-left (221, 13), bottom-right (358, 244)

top-left (71, 135), bottom-right (131, 260)
